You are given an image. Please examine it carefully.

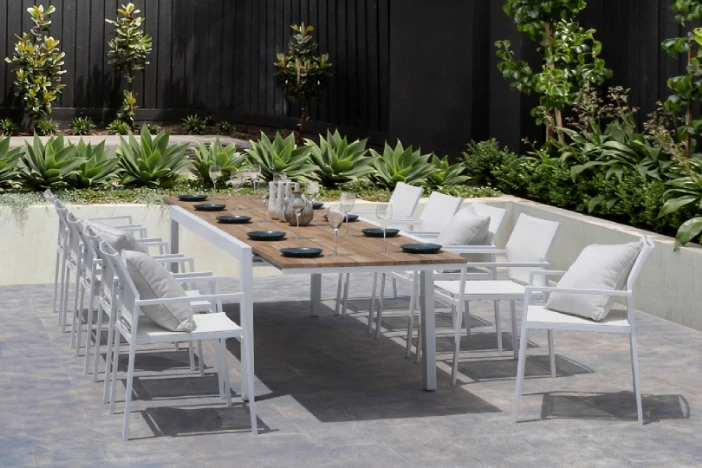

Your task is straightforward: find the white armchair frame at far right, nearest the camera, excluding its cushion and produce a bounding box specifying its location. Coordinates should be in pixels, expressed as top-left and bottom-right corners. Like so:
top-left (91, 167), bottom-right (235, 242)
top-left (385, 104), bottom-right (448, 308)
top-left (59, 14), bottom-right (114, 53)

top-left (512, 236), bottom-right (655, 423)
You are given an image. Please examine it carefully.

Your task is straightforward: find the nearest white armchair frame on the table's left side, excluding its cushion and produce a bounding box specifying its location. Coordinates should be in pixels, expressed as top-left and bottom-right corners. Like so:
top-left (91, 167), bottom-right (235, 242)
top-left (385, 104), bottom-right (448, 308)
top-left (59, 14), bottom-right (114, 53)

top-left (99, 242), bottom-right (258, 440)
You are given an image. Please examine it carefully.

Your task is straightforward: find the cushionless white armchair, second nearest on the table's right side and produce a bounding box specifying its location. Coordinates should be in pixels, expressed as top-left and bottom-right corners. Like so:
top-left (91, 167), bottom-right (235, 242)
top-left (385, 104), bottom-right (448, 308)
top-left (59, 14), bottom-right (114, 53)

top-left (434, 213), bottom-right (559, 385)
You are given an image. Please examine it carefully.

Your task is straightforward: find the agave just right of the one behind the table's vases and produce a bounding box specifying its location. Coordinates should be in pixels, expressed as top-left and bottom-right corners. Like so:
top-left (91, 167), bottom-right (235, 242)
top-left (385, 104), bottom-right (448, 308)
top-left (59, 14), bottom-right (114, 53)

top-left (305, 130), bottom-right (374, 188)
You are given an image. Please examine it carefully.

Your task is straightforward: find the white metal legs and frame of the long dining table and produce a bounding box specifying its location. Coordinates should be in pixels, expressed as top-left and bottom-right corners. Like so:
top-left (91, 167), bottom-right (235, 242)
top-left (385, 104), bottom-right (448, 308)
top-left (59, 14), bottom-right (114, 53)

top-left (169, 205), bottom-right (466, 392)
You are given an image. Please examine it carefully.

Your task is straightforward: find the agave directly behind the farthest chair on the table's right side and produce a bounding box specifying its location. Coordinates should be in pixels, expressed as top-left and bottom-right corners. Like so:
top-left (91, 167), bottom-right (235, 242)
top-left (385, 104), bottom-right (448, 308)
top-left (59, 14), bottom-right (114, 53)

top-left (371, 141), bottom-right (437, 189)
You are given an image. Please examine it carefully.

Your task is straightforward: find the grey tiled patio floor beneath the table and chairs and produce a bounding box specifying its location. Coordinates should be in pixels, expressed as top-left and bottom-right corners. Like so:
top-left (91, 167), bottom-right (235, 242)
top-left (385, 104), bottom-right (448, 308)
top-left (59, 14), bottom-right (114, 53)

top-left (0, 275), bottom-right (702, 467)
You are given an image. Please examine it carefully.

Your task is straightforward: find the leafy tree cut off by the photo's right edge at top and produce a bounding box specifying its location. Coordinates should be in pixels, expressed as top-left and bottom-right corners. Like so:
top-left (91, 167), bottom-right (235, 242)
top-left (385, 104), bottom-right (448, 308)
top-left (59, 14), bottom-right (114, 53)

top-left (661, 0), bottom-right (702, 158)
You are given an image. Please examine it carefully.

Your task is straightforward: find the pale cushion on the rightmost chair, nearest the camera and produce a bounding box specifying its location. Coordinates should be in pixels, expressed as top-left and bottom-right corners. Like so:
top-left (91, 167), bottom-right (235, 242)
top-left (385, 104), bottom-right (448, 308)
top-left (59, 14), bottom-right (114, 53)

top-left (546, 241), bottom-right (643, 321)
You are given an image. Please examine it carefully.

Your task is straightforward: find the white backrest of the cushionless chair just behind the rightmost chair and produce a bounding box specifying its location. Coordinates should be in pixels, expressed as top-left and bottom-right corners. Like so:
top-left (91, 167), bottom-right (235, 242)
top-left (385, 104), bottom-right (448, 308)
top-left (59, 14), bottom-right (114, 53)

top-left (506, 213), bottom-right (559, 286)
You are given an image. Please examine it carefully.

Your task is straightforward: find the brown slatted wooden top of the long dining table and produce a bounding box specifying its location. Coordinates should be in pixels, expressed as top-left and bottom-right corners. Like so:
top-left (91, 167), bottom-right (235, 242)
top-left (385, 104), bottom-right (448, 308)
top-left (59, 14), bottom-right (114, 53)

top-left (163, 196), bottom-right (465, 270)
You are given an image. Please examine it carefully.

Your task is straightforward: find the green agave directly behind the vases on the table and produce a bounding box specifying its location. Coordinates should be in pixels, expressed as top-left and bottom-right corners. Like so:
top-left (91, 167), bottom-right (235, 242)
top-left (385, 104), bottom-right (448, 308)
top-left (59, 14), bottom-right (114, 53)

top-left (246, 132), bottom-right (316, 180)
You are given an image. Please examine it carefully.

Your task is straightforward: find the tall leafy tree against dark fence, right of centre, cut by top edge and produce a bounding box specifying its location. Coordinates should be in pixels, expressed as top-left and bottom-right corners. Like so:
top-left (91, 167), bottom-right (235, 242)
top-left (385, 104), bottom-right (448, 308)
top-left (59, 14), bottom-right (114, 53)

top-left (495, 0), bottom-right (612, 142)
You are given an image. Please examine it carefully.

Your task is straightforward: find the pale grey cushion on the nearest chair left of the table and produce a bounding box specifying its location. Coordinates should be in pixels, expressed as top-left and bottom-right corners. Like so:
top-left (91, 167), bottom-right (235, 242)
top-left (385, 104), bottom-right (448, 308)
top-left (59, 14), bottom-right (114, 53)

top-left (122, 250), bottom-right (195, 332)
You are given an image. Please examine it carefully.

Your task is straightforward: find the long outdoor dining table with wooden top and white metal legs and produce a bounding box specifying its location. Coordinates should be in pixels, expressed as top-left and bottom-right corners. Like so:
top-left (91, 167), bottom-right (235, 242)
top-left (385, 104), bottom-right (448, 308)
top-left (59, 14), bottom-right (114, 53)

top-left (164, 196), bottom-right (465, 399)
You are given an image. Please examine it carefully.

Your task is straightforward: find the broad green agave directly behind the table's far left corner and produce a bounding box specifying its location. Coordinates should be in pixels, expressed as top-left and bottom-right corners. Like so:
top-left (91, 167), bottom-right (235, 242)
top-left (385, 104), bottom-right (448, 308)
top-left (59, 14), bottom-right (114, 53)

top-left (117, 127), bottom-right (190, 188)
